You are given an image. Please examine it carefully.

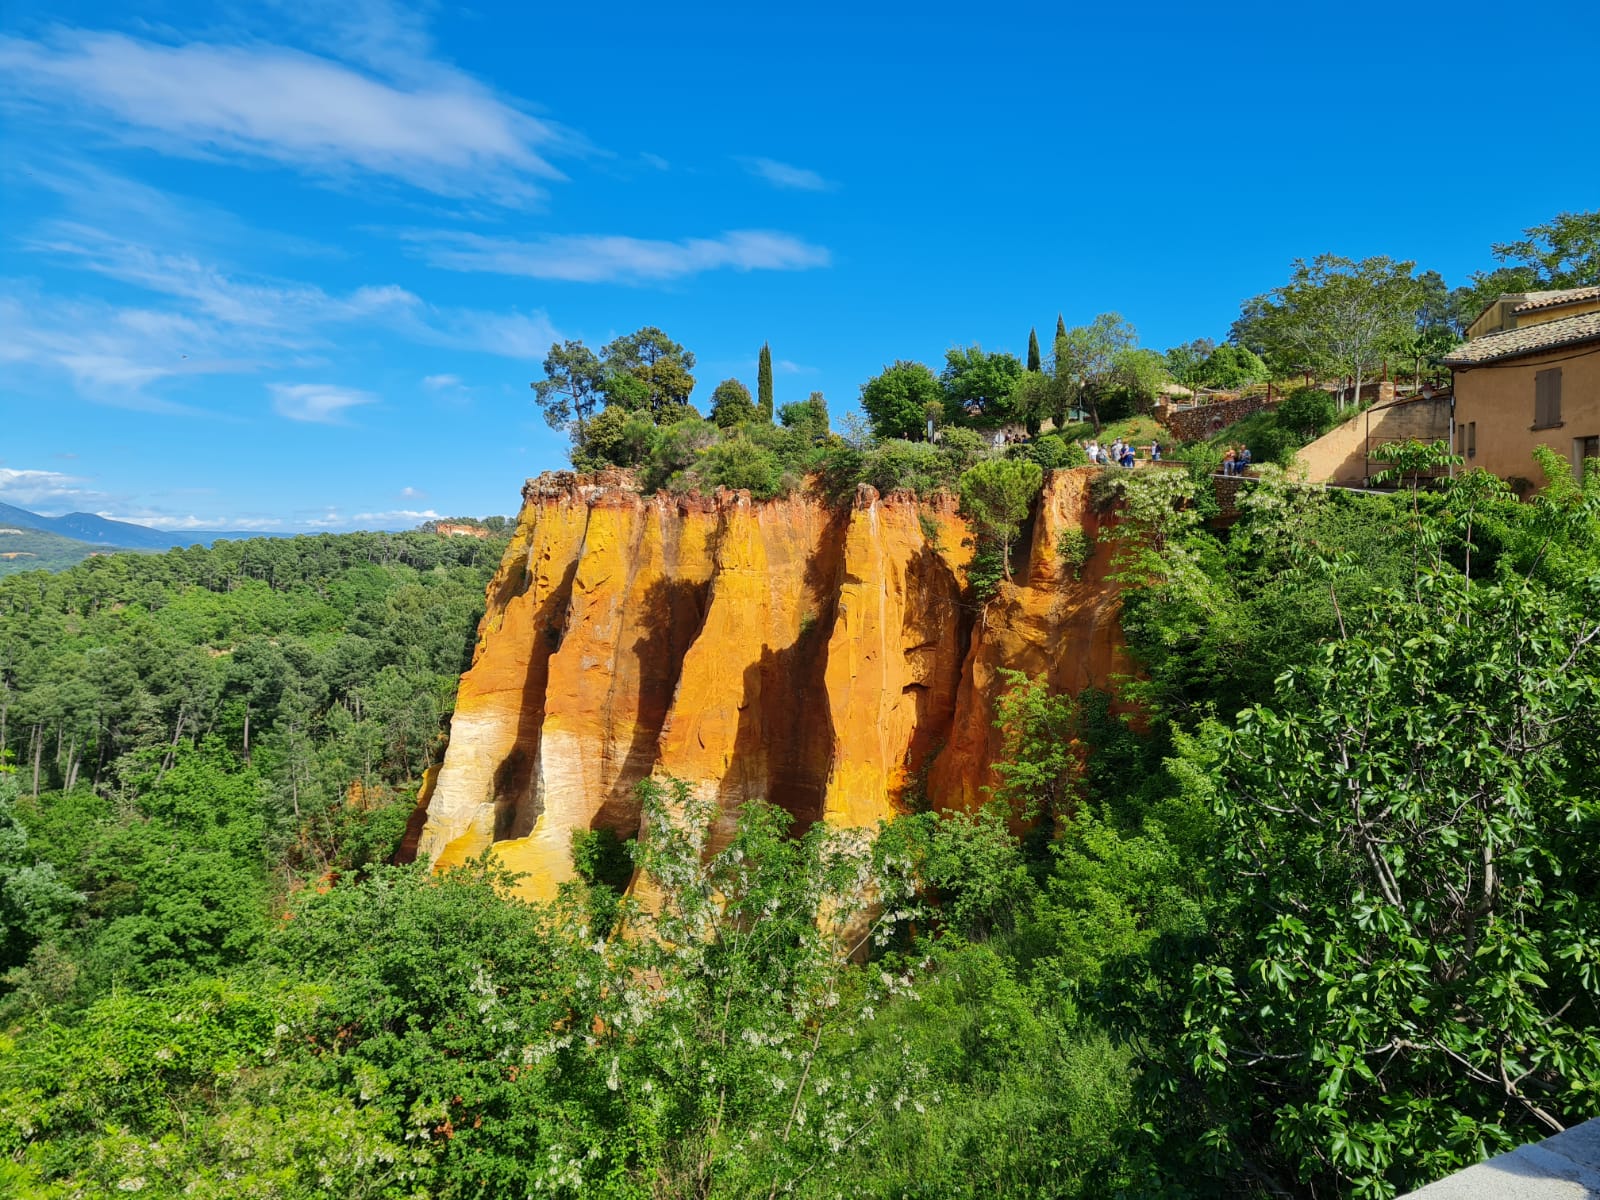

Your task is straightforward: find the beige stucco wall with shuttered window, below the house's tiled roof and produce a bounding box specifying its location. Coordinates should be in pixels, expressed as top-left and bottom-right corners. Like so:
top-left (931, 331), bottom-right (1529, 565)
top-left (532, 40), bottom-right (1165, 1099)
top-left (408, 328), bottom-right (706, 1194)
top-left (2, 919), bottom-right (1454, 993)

top-left (1456, 344), bottom-right (1600, 483)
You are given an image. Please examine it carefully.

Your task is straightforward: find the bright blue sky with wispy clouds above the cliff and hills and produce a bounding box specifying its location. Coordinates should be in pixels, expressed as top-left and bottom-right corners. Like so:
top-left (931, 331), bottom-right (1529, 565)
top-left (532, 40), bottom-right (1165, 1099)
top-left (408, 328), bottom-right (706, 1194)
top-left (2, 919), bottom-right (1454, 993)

top-left (0, 0), bottom-right (1600, 531)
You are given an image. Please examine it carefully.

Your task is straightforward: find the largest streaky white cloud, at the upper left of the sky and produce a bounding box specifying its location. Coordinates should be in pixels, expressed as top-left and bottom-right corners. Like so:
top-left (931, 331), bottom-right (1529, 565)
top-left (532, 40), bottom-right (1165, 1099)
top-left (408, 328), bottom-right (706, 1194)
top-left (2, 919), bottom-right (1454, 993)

top-left (0, 29), bottom-right (581, 205)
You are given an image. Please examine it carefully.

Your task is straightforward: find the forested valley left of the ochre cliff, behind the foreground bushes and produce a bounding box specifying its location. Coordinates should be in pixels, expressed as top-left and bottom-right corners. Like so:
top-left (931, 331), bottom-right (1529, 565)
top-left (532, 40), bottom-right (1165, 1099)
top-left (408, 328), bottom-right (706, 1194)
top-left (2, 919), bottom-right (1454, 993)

top-left (0, 534), bottom-right (504, 1003)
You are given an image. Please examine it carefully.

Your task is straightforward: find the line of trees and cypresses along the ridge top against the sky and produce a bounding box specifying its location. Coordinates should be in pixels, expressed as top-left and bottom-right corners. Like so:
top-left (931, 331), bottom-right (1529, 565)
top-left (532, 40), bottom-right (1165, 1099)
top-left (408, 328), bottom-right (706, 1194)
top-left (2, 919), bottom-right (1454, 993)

top-left (533, 210), bottom-right (1600, 474)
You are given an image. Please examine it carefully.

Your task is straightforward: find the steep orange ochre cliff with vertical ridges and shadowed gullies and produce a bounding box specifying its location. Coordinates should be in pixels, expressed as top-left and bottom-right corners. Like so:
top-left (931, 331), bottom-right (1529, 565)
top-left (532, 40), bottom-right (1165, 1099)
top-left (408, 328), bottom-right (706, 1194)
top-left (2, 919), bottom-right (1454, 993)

top-left (416, 469), bottom-right (1125, 896)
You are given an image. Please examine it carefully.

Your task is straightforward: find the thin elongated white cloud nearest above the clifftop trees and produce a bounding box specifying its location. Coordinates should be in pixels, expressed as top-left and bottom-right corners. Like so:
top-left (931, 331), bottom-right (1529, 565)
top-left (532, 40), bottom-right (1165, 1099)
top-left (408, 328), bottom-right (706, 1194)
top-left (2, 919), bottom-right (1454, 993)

top-left (402, 229), bottom-right (830, 283)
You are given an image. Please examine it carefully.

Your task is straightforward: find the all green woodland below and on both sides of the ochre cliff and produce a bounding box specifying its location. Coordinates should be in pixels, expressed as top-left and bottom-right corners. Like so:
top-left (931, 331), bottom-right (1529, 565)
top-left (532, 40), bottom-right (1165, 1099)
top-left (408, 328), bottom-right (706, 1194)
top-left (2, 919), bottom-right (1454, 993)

top-left (0, 445), bottom-right (1600, 1200)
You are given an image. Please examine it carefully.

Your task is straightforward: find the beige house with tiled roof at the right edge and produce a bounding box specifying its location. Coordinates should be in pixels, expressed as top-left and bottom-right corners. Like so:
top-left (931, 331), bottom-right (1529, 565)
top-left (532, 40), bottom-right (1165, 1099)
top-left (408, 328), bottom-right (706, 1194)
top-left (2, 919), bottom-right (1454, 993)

top-left (1443, 286), bottom-right (1600, 483)
